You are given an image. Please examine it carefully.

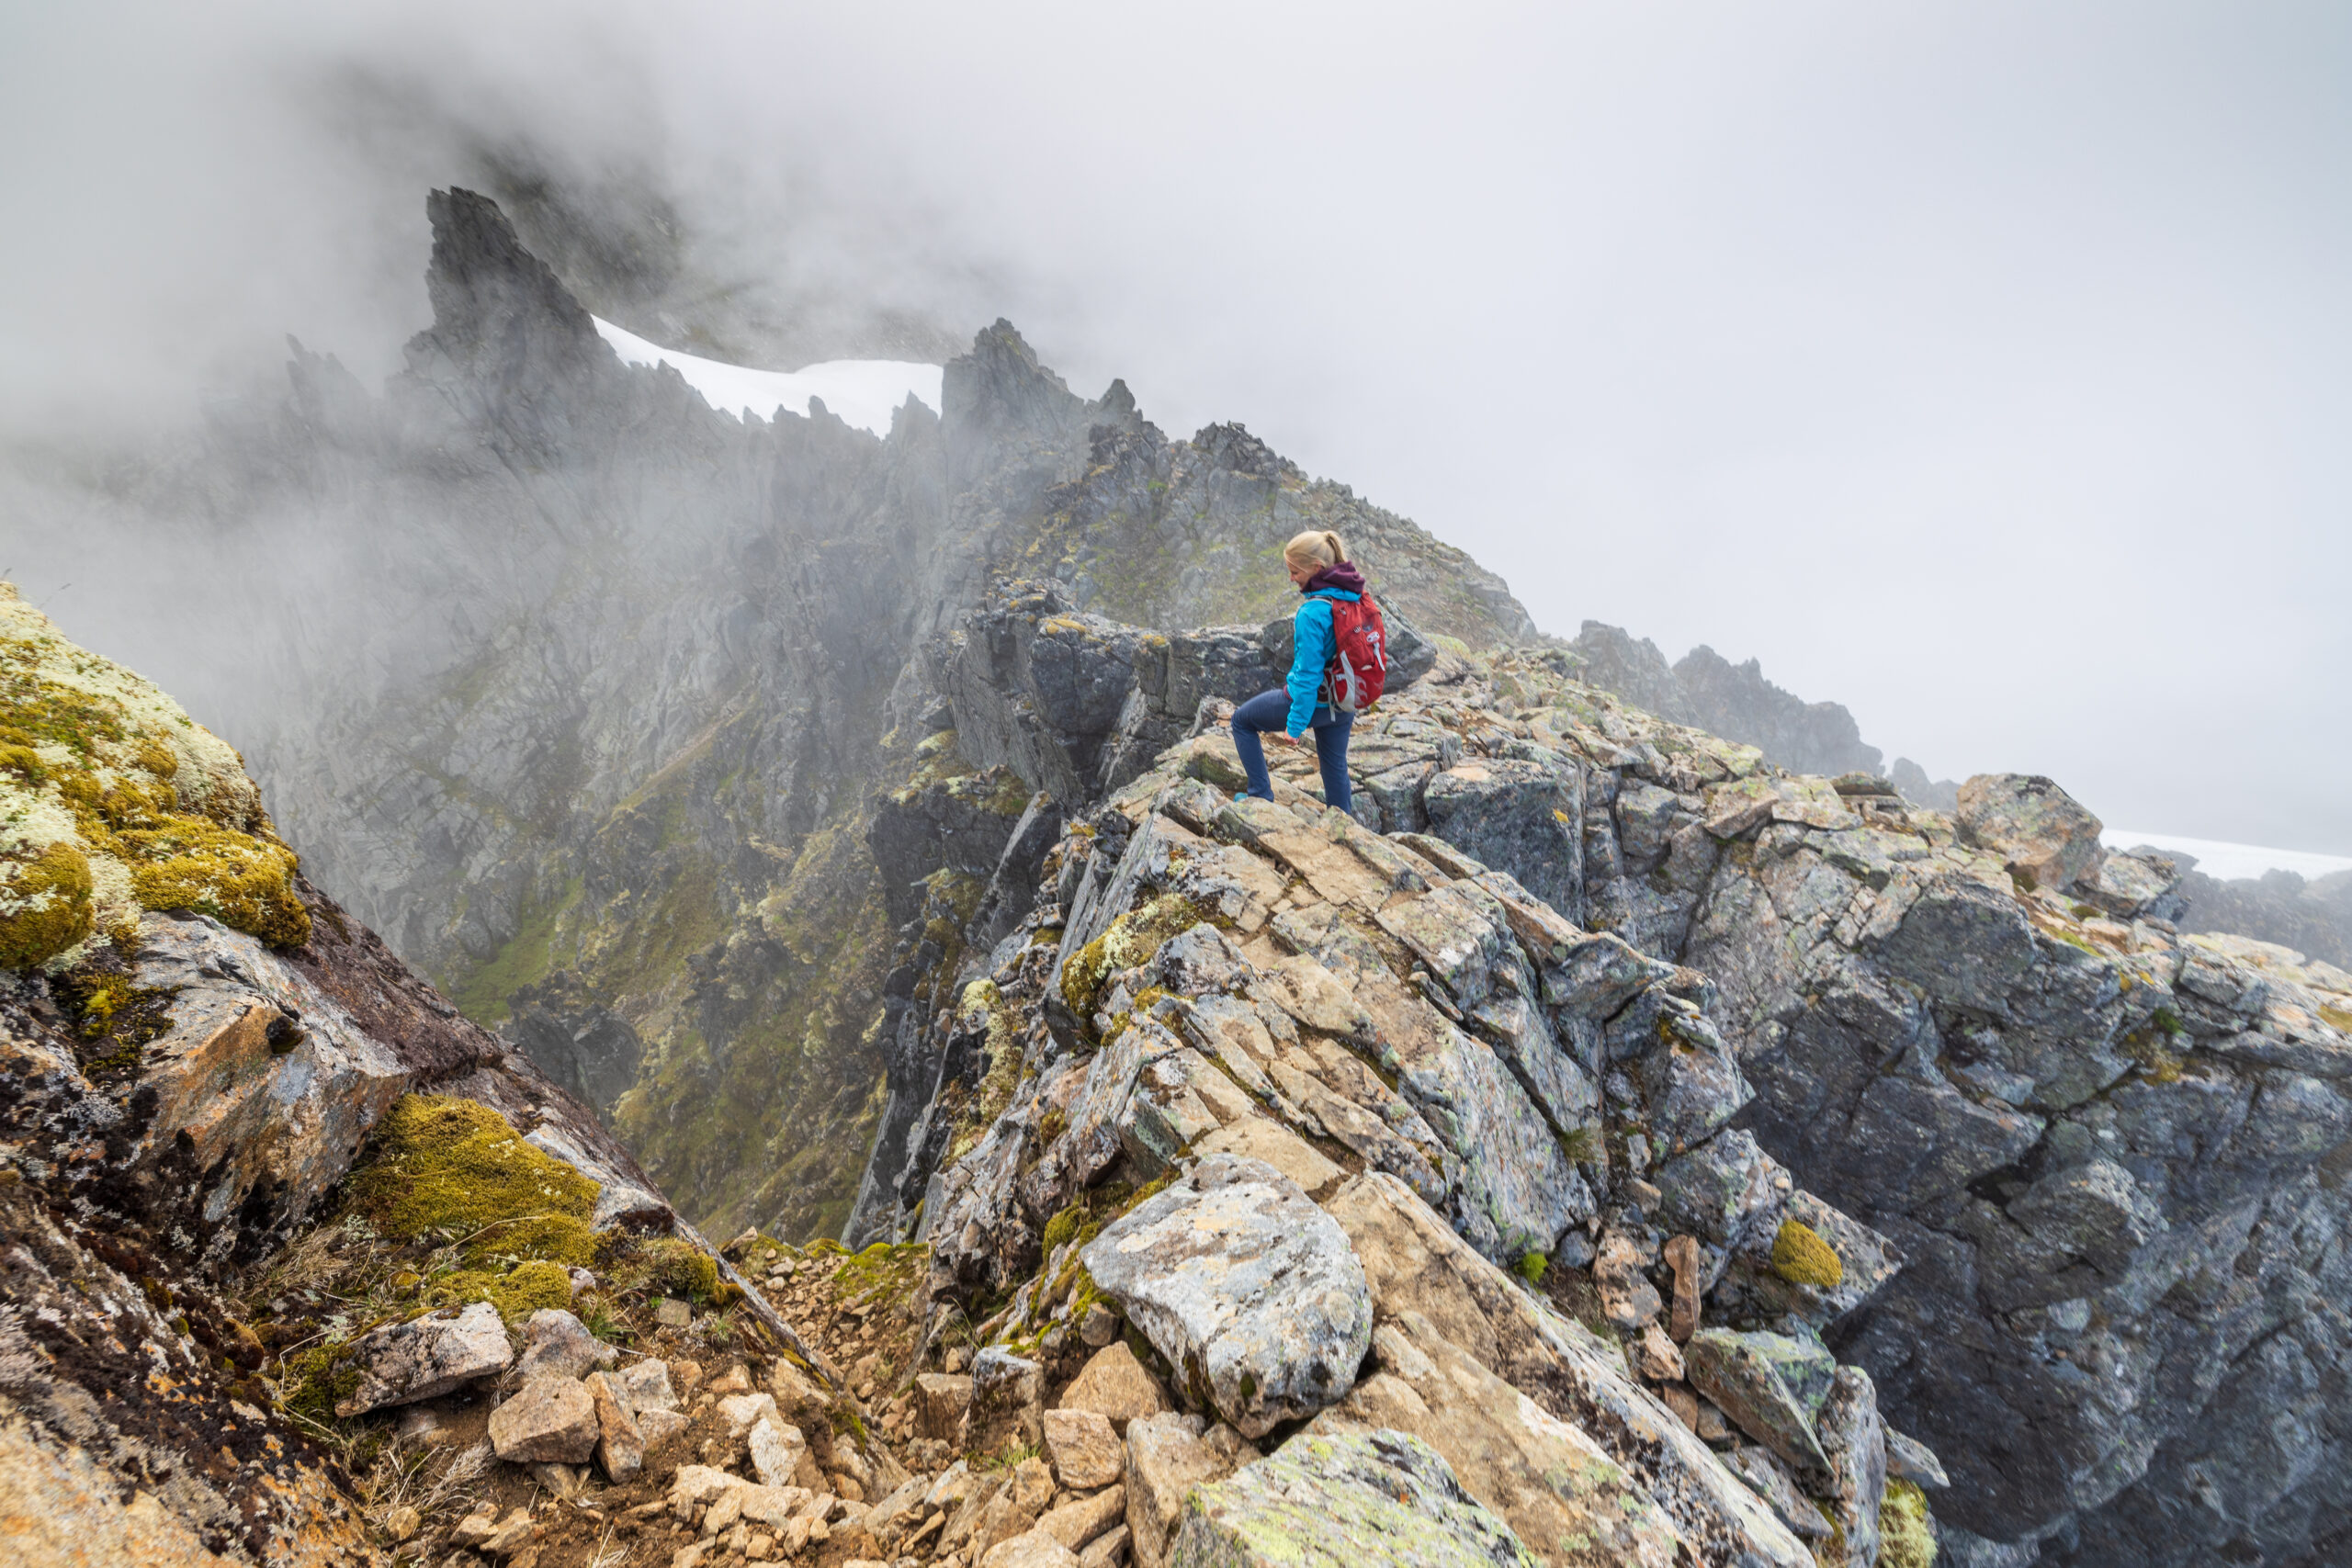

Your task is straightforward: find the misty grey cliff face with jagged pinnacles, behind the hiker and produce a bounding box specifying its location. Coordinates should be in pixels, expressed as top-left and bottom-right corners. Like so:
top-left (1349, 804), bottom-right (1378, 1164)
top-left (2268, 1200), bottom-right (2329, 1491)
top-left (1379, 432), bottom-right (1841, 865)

top-left (106, 190), bottom-right (1526, 1235)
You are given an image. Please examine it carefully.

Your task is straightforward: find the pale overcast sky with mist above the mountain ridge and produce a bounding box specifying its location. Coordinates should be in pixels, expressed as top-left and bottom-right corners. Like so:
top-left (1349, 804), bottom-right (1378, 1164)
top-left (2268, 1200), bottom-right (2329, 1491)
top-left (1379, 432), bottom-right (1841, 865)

top-left (0, 0), bottom-right (2352, 853)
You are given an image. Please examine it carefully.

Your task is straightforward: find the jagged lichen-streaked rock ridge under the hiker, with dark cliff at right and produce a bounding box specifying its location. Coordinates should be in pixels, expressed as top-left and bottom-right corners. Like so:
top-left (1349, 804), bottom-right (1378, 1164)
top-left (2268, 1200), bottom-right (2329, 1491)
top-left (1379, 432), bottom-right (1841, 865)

top-left (875, 590), bottom-right (2352, 1565)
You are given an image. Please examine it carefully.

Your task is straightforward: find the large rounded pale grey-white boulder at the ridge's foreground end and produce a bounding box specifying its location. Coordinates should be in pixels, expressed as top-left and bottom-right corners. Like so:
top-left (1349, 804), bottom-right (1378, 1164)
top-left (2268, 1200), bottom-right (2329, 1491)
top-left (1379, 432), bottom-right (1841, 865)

top-left (1081, 1155), bottom-right (1371, 1437)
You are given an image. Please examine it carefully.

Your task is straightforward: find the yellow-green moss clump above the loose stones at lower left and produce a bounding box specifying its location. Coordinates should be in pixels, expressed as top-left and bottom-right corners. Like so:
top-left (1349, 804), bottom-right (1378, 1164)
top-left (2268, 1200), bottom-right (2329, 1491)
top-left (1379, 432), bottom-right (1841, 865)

top-left (350, 1096), bottom-right (602, 1267)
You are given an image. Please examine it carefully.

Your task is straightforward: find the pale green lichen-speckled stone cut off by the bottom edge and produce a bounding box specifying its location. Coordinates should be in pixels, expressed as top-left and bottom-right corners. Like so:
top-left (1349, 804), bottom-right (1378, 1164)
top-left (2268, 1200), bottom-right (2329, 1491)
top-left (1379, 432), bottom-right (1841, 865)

top-left (1167, 1432), bottom-right (1536, 1568)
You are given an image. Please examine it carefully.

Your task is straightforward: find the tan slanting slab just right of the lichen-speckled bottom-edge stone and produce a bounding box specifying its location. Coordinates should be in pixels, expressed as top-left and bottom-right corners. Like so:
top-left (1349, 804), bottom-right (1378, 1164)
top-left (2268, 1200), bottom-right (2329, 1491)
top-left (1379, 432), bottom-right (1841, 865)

top-left (1307, 1312), bottom-right (1681, 1568)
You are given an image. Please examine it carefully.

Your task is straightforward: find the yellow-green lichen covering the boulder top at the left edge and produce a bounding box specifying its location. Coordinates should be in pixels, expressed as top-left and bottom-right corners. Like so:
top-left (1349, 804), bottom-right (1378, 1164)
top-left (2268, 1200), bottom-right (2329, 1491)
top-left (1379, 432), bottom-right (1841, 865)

top-left (0, 583), bottom-right (311, 968)
